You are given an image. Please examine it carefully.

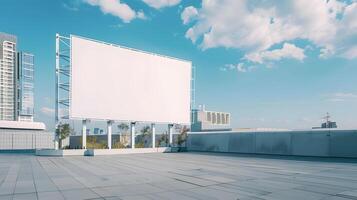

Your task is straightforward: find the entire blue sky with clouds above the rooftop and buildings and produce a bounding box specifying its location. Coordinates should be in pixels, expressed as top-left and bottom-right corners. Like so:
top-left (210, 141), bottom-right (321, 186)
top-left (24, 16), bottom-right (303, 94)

top-left (0, 0), bottom-right (357, 129)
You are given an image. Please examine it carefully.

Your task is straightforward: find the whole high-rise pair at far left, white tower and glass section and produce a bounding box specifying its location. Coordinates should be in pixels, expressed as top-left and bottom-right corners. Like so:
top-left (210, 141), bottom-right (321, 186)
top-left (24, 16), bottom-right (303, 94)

top-left (0, 33), bottom-right (35, 122)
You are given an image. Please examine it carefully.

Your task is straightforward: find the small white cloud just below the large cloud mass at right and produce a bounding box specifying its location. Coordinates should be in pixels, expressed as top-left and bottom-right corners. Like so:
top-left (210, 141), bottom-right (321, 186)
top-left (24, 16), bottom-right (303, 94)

top-left (245, 43), bottom-right (306, 64)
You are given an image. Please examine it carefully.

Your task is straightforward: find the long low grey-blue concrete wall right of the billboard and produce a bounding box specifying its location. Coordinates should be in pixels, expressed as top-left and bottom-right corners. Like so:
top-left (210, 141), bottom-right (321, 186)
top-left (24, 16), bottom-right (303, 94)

top-left (187, 130), bottom-right (357, 158)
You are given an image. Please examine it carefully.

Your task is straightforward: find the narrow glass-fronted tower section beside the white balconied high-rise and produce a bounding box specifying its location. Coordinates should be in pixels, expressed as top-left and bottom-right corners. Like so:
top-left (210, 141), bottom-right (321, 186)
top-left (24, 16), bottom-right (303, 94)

top-left (18, 52), bottom-right (34, 119)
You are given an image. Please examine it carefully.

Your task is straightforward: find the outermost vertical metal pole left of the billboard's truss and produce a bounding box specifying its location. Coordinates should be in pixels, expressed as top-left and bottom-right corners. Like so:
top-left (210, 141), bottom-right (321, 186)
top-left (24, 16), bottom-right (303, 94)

top-left (54, 33), bottom-right (60, 149)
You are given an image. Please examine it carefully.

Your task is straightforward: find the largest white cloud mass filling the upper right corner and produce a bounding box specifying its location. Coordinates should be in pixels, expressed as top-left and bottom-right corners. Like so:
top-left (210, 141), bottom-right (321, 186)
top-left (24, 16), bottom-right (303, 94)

top-left (182, 0), bottom-right (357, 60)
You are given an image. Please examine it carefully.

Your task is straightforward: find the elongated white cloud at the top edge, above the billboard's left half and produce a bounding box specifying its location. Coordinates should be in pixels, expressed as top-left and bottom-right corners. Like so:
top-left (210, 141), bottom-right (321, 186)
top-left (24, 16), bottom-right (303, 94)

top-left (84, 0), bottom-right (145, 23)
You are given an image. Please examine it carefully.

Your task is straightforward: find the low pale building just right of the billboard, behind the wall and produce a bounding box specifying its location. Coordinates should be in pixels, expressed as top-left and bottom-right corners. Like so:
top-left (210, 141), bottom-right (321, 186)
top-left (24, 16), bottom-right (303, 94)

top-left (191, 106), bottom-right (232, 132)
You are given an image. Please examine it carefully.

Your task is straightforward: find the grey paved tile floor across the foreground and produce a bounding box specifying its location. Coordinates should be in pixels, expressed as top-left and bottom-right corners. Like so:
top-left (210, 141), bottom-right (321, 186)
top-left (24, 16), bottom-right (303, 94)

top-left (0, 153), bottom-right (357, 200)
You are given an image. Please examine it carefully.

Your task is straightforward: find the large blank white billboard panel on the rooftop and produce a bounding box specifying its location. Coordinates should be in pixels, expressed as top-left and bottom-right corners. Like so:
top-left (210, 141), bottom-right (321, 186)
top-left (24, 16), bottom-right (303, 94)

top-left (69, 36), bottom-right (192, 124)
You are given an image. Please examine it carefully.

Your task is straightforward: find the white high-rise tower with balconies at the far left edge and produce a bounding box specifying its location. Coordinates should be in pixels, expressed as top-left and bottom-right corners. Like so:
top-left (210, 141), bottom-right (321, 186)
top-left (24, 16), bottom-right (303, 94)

top-left (0, 33), bottom-right (17, 120)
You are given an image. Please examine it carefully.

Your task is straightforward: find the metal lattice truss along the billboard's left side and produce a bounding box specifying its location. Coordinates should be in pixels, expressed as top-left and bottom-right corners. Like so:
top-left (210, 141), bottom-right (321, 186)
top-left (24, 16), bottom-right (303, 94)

top-left (55, 34), bottom-right (71, 128)
